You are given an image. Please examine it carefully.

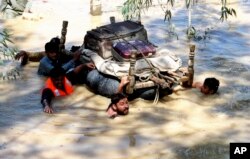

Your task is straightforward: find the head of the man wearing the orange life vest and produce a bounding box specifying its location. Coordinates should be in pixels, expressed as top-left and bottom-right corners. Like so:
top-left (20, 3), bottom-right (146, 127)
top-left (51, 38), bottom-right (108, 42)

top-left (49, 66), bottom-right (65, 89)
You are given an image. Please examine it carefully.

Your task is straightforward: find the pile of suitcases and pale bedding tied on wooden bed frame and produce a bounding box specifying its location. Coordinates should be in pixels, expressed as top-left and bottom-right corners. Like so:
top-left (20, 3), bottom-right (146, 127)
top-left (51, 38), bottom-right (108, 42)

top-left (82, 20), bottom-right (189, 99)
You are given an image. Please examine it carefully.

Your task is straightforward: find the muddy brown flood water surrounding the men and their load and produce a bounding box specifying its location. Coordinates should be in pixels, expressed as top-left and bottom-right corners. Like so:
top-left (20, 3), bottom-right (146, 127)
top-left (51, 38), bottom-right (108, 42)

top-left (0, 0), bottom-right (250, 159)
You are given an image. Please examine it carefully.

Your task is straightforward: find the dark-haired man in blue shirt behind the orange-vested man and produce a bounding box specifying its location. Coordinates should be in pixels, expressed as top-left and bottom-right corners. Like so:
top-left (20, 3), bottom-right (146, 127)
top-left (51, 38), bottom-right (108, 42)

top-left (16, 37), bottom-right (95, 84)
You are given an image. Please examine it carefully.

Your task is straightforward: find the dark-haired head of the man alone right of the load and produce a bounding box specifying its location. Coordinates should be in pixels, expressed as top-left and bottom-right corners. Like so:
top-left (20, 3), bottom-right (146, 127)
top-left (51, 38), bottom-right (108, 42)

top-left (201, 77), bottom-right (220, 94)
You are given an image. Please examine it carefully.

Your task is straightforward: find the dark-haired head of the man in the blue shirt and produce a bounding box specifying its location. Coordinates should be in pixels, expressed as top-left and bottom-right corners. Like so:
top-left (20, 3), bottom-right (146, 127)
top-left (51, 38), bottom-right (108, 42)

top-left (45, 41), bottom-right (59, 60)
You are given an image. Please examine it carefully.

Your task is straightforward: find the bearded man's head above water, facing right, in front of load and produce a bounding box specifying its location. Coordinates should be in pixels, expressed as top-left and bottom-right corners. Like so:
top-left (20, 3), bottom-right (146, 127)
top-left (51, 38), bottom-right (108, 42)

top-left (107, 93), bottom-right (129, 117)
